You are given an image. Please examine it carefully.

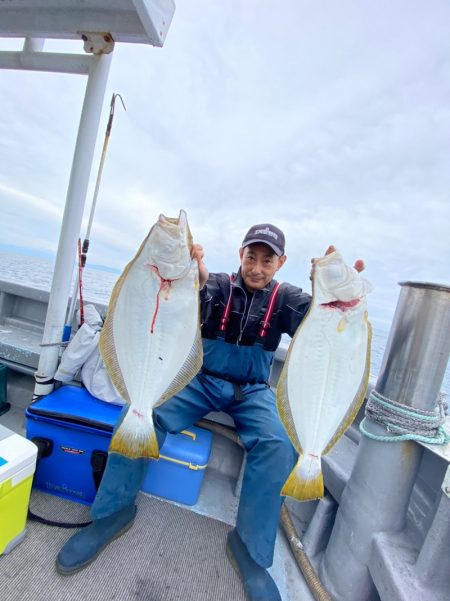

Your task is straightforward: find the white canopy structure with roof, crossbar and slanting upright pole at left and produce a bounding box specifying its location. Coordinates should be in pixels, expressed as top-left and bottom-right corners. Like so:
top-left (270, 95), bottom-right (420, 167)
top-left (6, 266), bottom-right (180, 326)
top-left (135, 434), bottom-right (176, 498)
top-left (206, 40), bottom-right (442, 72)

top-left (0, 0), bottom-right (175, 396)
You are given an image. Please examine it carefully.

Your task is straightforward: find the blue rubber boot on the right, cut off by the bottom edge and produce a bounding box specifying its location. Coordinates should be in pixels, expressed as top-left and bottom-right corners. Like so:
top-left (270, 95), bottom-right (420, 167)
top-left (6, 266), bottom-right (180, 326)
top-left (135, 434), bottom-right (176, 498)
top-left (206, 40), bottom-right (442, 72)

top-left (227, 530), bottom-right (281, 601)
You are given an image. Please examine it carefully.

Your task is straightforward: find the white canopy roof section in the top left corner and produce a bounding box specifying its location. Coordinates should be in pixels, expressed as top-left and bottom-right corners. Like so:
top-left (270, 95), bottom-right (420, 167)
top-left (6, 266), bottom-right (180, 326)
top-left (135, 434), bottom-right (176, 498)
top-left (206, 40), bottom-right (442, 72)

top-left (0, 0), bottom-right (175, 46)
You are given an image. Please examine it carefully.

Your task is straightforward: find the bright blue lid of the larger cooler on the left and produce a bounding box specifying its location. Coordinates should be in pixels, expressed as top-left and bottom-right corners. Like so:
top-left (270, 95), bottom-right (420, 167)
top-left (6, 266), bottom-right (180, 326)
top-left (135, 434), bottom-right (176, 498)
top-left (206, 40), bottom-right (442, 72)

top-left (26, 386), bottom-right (122, 432)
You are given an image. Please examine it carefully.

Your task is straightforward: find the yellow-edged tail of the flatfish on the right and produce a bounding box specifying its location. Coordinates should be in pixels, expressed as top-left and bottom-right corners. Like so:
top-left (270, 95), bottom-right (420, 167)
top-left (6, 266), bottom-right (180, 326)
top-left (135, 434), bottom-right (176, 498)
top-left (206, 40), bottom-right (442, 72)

top-left (281, 454), bottom-right (324, 501)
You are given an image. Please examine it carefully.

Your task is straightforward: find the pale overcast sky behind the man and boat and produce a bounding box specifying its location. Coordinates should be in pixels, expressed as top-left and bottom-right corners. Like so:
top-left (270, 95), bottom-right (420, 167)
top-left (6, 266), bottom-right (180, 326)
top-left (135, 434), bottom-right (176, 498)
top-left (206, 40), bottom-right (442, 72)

top-left (0, 0), bottom-right (450, 328)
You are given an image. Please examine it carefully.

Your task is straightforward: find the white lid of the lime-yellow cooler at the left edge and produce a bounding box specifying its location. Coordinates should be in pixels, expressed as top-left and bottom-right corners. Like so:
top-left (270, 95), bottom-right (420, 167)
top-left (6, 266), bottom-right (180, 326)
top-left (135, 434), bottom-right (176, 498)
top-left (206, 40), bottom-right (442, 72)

top-left (0, 425), bottom-right (37, 484)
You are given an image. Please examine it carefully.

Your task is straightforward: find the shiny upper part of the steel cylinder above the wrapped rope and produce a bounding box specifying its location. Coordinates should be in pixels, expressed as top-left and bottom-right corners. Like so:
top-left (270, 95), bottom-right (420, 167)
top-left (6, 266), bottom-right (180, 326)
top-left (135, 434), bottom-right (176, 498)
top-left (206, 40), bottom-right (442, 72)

top-left (376, 282), bottom-right (450, 410)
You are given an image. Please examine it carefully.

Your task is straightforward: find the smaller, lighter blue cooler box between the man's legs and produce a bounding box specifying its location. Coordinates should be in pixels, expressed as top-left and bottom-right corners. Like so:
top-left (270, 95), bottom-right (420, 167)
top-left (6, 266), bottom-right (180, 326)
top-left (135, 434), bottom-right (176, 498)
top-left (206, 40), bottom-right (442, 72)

top-left (142, 426), bottom-right (212, 505)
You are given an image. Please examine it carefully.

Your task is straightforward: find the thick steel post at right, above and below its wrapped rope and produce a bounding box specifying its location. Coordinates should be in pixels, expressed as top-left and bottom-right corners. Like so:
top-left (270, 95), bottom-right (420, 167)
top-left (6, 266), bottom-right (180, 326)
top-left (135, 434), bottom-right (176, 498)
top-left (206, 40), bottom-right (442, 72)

top-left (321, 282), bottom-right (450, 601)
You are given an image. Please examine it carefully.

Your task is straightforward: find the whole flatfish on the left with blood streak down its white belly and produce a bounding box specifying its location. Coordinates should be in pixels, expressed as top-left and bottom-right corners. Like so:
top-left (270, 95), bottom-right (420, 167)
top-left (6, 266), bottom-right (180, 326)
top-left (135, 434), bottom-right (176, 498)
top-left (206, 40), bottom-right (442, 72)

top-left (99, 211), bottom-right (202, 458)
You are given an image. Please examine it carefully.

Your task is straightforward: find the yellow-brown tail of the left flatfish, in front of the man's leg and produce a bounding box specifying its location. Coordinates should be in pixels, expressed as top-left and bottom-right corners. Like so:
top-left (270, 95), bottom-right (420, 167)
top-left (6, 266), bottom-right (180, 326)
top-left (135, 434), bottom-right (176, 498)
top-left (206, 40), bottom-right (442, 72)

top-left (109, 407), bottom-right (159, 459)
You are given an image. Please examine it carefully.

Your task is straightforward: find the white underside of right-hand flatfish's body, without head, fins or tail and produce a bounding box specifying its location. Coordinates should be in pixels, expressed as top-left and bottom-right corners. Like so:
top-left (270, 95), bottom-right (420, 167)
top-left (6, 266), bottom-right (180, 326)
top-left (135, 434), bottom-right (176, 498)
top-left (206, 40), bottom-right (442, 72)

top-left (287, 306), bottom-right (368, 455)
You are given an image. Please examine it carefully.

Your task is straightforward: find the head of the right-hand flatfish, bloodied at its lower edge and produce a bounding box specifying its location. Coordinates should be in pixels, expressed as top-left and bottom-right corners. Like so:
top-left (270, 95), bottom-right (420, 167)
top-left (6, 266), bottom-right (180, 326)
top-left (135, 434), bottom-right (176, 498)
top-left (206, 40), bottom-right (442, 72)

top-left (312, 250), bottom-right (372, 308)
